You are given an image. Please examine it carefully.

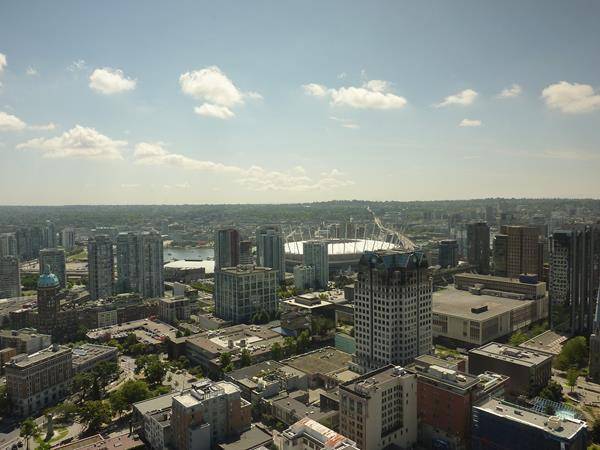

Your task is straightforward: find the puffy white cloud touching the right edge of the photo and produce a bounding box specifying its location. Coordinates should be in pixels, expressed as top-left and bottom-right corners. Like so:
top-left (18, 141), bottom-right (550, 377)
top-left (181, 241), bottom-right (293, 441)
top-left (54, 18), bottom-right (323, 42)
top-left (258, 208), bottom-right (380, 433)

top-left (542, 81), bottom-right (600, 114)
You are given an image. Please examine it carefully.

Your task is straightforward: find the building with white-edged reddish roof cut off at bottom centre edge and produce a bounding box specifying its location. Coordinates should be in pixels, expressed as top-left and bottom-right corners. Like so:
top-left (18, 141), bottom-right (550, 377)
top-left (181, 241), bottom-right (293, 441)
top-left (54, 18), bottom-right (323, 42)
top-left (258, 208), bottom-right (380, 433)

top-left (273, 417), bottom-right (359, 450)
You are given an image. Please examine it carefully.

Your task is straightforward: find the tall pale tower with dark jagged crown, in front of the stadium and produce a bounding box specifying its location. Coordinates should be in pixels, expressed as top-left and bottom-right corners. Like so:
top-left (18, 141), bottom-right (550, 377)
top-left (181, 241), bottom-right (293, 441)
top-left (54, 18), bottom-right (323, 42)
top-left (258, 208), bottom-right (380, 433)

top-left (354, 250), bottom-right (432, 373)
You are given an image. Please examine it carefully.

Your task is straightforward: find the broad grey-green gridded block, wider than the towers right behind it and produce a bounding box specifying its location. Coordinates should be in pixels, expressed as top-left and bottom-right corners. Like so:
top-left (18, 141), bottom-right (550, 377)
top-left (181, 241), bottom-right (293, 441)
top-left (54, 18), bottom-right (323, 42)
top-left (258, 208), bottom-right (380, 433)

top-left (214, 266), bottom-right (278, 323)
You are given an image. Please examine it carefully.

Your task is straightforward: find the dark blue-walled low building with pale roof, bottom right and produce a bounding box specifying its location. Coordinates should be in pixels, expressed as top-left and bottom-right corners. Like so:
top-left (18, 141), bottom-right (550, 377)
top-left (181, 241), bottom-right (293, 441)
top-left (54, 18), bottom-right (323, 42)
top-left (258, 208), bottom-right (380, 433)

top-left (471, 397), bottom-right (587, 450)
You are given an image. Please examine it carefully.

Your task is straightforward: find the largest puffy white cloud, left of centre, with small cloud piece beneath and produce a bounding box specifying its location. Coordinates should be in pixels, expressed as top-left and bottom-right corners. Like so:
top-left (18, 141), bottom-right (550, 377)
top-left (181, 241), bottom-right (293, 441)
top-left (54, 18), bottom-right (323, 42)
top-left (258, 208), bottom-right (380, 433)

top-left (179, 66), bottom-right (262, 119)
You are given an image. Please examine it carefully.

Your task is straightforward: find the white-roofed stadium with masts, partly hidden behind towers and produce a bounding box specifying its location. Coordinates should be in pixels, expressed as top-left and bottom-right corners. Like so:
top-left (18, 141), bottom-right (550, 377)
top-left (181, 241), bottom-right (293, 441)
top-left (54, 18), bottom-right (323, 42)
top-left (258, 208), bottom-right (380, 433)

top-left (284, 238), bottom-right (398, 273)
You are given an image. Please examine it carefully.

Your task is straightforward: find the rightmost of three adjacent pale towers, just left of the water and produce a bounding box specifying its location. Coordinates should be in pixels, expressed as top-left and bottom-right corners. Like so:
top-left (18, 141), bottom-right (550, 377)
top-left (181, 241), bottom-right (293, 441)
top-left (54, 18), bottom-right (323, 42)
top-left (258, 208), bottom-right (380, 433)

top-left (139, 231), bottom-right (165, 297)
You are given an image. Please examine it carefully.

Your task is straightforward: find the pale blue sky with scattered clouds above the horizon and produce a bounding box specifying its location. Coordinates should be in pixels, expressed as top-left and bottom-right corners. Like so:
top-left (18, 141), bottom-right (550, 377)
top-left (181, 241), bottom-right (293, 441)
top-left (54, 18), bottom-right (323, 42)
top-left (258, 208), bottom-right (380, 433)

top-left (0, 0), bottom-right (600, 204)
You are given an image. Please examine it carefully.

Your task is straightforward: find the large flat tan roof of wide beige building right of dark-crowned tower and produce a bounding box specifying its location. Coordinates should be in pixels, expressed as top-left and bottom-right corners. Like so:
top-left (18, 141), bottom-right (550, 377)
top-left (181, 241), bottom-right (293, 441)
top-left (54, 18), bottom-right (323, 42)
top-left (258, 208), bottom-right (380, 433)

top-left (431, 286), bottom-right (533, 321)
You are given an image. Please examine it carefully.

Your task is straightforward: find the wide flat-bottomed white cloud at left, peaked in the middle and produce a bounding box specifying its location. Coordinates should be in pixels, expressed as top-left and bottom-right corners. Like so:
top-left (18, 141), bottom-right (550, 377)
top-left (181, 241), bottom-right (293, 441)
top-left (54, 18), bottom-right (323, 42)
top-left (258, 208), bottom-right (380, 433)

top-left (17, 125), bottom-right (127, 159)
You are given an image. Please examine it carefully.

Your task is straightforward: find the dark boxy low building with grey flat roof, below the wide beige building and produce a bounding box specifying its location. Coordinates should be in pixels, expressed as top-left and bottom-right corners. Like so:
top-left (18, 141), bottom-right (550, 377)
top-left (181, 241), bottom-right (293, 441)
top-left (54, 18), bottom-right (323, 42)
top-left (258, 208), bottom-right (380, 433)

top-left (469, 342), bottom-right (552, 396)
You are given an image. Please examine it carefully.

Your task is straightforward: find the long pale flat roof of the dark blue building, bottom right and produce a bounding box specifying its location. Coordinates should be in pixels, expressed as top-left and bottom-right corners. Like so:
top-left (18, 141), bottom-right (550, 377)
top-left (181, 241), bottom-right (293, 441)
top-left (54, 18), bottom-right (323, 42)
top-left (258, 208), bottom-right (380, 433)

top-left (473, 398), bottom-right (587, 439)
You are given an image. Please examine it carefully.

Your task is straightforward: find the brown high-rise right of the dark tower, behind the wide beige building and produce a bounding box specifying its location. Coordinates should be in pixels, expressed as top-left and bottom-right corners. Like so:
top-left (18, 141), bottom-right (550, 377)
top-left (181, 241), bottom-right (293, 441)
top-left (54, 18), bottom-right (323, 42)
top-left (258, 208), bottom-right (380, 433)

top-left (500, 225), bottom-right (544, 278)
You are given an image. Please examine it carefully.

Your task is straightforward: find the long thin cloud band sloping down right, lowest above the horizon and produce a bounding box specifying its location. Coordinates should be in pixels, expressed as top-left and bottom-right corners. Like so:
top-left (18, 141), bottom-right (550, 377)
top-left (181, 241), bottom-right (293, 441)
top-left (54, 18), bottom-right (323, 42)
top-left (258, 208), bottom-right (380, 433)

top-left (134, 142), bottom-right (353, 191)
